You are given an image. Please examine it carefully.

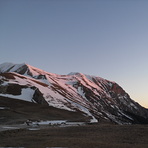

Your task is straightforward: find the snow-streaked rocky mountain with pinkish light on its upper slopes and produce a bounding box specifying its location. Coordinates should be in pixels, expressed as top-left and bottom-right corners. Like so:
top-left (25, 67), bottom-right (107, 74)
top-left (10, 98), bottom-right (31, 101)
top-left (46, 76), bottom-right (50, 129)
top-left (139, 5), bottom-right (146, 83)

top-left (0, 63), bottom-right (148, 124)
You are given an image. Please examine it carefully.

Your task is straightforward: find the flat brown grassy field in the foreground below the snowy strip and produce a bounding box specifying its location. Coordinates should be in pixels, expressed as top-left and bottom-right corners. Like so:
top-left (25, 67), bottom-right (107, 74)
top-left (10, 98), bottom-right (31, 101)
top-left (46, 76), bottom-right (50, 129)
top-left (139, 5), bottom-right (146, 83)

top-left (0, 124), bottom-right (148, 148)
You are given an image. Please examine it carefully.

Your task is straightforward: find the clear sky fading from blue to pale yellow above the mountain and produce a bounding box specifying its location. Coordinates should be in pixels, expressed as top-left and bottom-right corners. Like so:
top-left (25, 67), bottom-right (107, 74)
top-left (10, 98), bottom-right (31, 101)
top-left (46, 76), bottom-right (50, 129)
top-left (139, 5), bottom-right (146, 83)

top-left (0, 0), bottom-right (148, 108)
